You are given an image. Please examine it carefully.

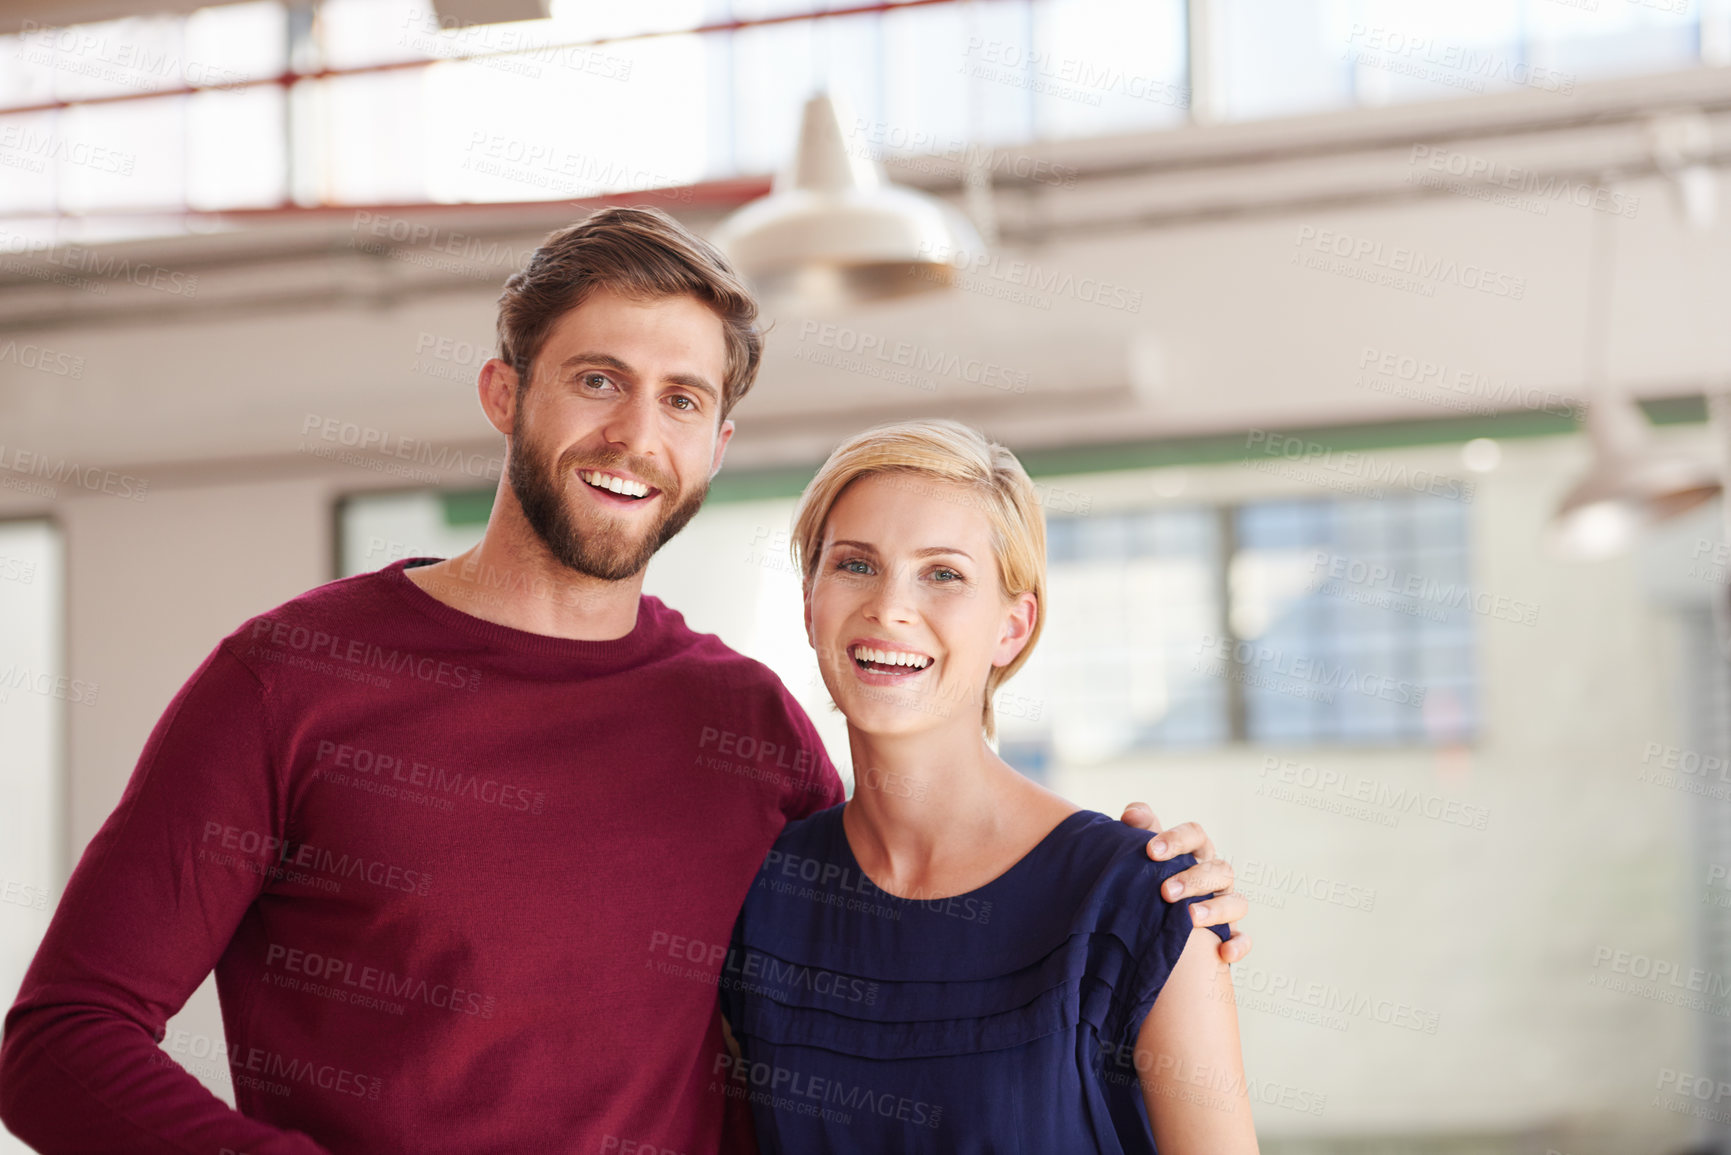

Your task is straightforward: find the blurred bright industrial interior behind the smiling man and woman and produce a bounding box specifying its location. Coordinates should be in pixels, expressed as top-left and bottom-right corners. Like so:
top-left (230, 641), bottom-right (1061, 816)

top-left (0, 0), bottom-right (1731, 1155)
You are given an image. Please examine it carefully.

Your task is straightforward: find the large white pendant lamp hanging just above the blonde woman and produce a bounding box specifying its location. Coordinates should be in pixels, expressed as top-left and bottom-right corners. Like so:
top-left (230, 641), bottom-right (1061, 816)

top-left (715, 94), bottom-right (985, 305)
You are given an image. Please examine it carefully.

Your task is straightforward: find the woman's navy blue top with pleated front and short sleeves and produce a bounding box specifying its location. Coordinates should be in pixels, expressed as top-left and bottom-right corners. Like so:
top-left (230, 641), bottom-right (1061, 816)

top-left (722, 805), bottom-right (1229, 1155)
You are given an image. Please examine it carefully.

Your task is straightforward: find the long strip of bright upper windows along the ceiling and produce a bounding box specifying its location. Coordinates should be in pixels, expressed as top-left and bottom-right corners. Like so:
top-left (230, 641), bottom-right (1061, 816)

top-left (0, 0), bottom-right (1731, 236)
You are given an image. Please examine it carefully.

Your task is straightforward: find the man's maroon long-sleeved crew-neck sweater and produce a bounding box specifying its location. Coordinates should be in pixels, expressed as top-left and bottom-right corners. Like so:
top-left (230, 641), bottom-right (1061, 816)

top-left (0, 561), bottom-right (841, 1155)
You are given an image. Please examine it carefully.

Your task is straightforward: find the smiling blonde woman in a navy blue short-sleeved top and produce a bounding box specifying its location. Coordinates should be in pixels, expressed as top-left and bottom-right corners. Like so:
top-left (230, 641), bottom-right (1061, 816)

top-left (722, 421), bottom-right (1257, 1155)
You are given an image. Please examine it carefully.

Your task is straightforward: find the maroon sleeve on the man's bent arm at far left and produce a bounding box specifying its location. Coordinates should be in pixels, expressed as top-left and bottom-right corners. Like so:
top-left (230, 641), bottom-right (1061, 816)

top-left (0, 646), bottom-right (324, 1155)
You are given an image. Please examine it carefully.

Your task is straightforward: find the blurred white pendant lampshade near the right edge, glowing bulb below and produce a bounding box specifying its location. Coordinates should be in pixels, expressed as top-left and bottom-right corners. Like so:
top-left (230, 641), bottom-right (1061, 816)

top-left (1551, 395), bottom-right (1721, 559)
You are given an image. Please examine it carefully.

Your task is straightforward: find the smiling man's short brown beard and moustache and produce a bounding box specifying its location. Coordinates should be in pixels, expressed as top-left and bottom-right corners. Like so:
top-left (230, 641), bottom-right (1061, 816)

top-left (509, 409), bottom-right (710, 582)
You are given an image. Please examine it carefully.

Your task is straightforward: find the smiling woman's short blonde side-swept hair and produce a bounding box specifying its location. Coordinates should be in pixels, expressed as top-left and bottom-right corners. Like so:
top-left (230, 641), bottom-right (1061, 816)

top-left (791, 419), bottom-right (1046, 738)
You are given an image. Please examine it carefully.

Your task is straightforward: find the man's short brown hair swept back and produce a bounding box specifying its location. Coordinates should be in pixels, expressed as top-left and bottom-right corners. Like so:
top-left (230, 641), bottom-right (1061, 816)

top-left (499, 208), bottom-right (763, 421)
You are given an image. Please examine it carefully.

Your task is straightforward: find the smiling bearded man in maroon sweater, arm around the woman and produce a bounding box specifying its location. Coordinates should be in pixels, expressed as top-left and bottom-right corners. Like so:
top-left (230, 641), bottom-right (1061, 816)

top-left (0, 210), bottom-right (1246, 1155)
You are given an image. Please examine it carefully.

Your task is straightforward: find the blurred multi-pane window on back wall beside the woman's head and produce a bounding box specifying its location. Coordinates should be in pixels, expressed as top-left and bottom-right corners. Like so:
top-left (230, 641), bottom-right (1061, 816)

top-left (1001, 495), bottom-right (1482, 764)
